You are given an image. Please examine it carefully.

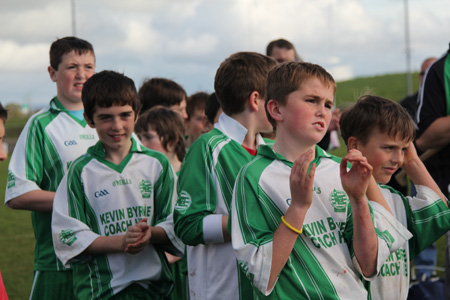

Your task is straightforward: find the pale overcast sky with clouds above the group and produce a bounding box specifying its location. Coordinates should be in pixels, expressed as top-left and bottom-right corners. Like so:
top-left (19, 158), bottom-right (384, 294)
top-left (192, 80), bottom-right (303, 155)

top-left (0, 0), bottom-right (450, 107)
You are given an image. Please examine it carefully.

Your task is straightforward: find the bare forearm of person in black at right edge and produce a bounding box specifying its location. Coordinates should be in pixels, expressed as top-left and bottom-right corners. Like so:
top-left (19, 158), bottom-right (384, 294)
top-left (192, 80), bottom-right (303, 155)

top-left (416, 116), bottom-right (450, 151)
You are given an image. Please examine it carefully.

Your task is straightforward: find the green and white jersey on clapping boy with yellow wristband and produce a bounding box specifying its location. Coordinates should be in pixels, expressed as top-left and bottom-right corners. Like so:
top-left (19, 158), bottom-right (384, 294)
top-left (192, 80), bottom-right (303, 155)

top-left (231, 146), bottom-right (409, 300)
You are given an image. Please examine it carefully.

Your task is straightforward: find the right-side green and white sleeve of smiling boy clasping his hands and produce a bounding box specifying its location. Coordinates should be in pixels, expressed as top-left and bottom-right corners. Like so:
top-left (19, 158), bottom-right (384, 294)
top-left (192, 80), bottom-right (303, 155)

top-left (152, 161), bottom-right (185, 256)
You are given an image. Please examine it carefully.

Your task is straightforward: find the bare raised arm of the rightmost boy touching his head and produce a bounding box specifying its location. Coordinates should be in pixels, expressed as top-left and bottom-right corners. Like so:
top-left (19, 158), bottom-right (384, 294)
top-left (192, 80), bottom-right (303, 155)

top-left (402, 141), bottom-right (450, 206)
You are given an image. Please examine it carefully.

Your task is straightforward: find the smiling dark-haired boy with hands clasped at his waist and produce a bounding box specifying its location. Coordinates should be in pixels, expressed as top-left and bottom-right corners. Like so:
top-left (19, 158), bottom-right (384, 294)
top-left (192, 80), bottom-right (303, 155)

top-left (52, 71), bottom-right (184, 299)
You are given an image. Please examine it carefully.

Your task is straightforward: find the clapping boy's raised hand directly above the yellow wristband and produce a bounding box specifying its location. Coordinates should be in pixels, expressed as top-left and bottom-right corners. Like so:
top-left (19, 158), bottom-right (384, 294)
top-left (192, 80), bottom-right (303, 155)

top-left (289, 149), bottom-right (316, 209)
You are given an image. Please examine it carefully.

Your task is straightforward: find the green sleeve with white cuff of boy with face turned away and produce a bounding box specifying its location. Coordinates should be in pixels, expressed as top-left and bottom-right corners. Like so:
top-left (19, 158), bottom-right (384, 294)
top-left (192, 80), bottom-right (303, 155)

top-left (174, 140), bottom-right (223, 246)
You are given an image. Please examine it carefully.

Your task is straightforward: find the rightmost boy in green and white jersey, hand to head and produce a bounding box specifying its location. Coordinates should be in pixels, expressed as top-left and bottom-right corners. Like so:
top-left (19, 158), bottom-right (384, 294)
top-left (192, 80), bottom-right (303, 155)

top-left (341, 95), bottom-right (450, 299)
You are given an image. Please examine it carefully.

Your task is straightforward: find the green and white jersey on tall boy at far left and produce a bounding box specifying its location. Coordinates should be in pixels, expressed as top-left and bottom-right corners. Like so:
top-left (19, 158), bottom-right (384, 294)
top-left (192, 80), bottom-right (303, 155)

top-left (5, 97), bottom-right (98, 271)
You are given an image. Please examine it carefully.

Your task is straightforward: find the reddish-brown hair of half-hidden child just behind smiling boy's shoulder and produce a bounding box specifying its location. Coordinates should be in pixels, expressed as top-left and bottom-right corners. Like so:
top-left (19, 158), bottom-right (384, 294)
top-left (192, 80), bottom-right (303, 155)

top-left (134, 105), bottom-right (186, 161)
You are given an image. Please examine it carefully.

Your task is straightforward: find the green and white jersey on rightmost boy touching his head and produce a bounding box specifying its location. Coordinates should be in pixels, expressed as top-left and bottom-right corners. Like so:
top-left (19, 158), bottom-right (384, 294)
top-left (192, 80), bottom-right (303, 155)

top-left (370, 185), bottom-right (450, 300)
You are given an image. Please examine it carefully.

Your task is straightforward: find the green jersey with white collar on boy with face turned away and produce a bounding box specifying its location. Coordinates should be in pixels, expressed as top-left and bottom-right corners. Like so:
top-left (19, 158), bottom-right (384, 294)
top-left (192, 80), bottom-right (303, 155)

top-left (174, 113), bottom-right (264, 300)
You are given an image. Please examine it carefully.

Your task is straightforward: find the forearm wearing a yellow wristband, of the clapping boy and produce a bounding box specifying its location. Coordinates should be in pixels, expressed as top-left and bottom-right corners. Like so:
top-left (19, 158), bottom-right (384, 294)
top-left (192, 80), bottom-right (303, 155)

top-left (268, 206), bottom-right (307, 289)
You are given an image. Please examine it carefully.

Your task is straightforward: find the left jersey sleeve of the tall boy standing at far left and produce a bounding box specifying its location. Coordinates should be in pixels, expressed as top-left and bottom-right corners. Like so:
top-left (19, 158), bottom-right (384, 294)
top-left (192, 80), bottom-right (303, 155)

top-left (5, 113), bottom-right (44, 205)
